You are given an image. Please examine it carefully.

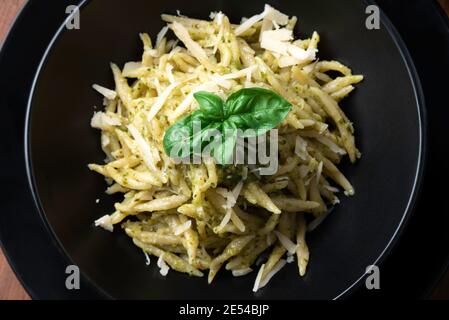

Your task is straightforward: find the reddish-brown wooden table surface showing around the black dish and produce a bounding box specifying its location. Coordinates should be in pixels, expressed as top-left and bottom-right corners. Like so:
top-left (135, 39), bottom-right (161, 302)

top-left (0, 0), bottom-right (449, 300)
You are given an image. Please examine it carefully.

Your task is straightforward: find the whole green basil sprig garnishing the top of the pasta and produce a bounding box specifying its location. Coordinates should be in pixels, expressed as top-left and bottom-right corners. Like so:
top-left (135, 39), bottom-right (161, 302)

top-left (164, 88), bottom-right (292, 163)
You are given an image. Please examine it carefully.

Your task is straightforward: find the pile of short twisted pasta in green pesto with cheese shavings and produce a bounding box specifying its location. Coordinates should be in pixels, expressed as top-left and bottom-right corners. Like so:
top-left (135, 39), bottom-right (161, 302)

top-left (89, 5), bottom-right (363, 291)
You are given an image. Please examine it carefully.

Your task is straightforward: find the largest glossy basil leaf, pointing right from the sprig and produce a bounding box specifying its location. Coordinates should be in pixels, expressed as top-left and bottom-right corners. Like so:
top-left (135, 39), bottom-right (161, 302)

top-left (224, 88), bottom-right (292, 137)
